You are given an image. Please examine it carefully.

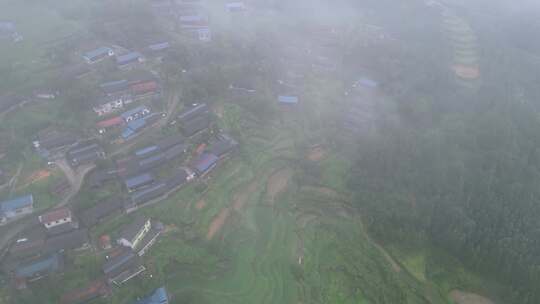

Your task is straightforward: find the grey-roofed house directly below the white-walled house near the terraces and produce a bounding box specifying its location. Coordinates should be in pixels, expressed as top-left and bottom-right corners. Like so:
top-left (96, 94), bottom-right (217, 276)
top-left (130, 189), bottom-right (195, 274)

top-left (103, 249), bottom-right (146, 286)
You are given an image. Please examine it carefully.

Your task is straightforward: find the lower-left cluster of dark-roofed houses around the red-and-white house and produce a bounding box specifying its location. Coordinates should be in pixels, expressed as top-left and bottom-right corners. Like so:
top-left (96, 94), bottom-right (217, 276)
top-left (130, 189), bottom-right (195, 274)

top-left (2, 208), bottom-right (90, 289)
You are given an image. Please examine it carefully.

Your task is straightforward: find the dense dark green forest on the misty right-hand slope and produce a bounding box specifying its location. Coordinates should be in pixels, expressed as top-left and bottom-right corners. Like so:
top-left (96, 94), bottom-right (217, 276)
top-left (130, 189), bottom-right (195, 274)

top-left (349, 1), bottom-right (540, 303)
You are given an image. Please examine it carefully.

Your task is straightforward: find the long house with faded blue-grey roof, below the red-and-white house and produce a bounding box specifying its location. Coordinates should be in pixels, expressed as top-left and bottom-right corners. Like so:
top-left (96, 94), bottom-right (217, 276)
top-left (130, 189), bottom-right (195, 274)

top-left (14, 254), bottom-right (64, 282)
